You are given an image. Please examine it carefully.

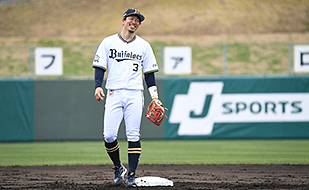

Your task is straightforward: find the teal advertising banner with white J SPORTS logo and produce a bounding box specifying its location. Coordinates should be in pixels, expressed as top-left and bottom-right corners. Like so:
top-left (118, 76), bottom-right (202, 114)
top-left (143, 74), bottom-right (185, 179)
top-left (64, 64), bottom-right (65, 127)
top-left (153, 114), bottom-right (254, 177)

top-left (164, 77), bottom-right (309, 139)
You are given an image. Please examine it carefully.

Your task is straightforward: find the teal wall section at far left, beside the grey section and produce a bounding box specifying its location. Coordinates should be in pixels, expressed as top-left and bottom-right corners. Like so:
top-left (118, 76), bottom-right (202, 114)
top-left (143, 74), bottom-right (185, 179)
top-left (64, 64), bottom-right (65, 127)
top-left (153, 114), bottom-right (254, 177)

top-left (0, 80), bottom-right (34, 142)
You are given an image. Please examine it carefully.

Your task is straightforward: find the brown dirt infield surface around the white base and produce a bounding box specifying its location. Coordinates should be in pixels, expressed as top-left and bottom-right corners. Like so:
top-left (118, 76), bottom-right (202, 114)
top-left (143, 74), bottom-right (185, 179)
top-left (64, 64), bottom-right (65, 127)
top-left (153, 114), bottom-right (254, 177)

top-left (0, 165), bottom-right (309, 190)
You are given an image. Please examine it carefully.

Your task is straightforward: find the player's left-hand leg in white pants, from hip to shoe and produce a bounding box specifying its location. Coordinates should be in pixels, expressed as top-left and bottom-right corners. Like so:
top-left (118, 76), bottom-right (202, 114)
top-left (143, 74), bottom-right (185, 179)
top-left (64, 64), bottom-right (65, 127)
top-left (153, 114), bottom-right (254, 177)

top-left (103, 91), bottom-right (127, 184)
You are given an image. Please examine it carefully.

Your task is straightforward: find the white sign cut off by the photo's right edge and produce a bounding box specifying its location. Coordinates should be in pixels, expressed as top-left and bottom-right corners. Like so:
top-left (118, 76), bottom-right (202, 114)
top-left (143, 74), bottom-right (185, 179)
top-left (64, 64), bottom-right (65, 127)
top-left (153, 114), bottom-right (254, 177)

top-left (294, 45), bottom-right (309, 73)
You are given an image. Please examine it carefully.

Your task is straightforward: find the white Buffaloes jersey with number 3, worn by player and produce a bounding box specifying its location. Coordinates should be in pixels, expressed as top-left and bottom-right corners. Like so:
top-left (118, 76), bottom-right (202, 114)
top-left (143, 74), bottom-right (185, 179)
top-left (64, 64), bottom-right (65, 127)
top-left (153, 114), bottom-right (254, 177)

top-left (93, 33), bottom-right (159, 90)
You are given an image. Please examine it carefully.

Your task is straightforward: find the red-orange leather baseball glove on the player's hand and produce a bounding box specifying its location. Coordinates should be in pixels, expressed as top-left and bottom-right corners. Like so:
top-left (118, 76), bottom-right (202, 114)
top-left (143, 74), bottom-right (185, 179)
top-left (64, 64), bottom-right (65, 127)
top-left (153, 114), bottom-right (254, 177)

top-left (145, 100), bottom-right (167, 126)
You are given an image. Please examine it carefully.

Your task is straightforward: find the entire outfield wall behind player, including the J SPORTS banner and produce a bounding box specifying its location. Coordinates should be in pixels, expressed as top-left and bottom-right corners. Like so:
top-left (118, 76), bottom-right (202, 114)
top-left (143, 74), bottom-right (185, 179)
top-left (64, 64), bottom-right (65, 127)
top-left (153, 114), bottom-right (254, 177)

top-left (0, 76), bottom-right (309, 142)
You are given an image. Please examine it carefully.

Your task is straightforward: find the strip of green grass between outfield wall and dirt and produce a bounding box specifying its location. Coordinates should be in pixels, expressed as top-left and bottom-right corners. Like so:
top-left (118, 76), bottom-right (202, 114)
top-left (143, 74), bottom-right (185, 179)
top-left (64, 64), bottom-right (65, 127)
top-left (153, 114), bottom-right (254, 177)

top-left (0, 140), bottom-right (309, 166)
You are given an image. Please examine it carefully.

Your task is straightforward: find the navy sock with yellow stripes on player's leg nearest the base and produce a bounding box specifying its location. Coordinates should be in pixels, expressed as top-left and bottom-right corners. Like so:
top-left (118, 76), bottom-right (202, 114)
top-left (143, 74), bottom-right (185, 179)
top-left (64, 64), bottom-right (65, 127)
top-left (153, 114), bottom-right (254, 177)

top-left (128, 141), bottom-right (142, 175)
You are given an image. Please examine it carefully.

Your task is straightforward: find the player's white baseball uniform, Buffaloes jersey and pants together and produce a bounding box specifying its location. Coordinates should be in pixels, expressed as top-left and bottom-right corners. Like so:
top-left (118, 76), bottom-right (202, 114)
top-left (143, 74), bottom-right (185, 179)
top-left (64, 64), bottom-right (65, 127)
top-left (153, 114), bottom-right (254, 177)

top-left (93, 34), bottom-right (158, 143)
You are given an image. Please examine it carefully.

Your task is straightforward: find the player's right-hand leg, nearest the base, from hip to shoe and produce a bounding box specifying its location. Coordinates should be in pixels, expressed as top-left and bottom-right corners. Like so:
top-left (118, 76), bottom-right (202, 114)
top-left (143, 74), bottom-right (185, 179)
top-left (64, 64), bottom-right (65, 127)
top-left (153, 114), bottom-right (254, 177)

top-left (124, 90), bottom-right (144, 186)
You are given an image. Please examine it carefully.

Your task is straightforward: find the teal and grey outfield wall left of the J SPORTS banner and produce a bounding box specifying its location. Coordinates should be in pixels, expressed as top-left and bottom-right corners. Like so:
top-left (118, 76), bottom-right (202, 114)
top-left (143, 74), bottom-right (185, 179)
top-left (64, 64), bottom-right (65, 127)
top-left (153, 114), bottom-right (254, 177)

top-left (0, 80), bottom-right (163, 142)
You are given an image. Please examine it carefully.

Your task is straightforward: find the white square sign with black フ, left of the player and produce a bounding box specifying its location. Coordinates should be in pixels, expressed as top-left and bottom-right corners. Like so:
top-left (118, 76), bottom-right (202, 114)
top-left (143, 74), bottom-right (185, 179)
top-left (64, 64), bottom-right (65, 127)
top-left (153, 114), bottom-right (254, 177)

top-left (35, 47), bottom-right (63, 76)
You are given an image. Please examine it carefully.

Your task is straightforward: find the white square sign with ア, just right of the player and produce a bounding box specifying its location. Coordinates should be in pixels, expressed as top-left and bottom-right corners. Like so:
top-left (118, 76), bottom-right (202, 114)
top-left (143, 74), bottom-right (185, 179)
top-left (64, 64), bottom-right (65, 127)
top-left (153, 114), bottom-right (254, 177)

top-left (164, 47), bottom-right (192, 75)
